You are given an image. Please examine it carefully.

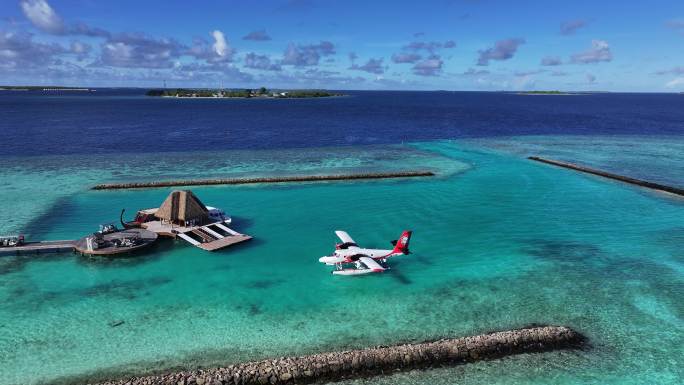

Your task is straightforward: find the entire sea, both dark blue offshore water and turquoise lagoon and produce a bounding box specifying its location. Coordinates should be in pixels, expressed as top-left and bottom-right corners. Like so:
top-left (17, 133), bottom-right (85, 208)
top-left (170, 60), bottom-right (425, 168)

top-left (0, 90), bottom-right (684, 385)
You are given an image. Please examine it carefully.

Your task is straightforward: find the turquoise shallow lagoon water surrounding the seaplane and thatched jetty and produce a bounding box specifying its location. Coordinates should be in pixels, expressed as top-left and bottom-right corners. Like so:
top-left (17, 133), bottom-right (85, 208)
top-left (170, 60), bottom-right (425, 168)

top-left (0, 138), bottom-right (684, 384)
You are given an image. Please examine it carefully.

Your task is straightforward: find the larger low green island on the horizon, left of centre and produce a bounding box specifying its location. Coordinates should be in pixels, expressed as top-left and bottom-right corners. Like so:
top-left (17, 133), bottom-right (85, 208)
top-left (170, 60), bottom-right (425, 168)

top-left (146, 87), bottom-right (344, 99)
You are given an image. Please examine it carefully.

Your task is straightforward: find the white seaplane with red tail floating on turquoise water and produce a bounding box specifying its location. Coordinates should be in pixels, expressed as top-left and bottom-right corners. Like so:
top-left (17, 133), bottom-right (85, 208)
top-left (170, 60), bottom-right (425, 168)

top-left (318, 230), bottom-right (411, 275)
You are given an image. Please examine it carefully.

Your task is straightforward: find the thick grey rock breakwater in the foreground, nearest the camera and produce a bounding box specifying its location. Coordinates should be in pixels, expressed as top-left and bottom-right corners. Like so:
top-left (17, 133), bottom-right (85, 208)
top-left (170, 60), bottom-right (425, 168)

top-left (91, 326), bottom-right (585, 385)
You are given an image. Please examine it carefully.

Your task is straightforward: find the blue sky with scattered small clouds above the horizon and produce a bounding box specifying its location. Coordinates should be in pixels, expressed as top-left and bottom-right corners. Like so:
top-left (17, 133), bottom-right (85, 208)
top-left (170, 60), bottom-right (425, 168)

top-left (0, 0), bottom-right (684, 92)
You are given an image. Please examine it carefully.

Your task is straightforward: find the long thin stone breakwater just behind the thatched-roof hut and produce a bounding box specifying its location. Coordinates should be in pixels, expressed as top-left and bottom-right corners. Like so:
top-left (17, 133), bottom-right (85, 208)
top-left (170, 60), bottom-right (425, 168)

top-left (92, 171), bottom-right (435, 190)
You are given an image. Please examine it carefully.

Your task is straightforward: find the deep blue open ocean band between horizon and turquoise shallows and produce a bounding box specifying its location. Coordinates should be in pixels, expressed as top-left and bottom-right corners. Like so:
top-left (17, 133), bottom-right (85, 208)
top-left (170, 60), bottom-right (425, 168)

top-left (0, 89), bottom-right (684, 156)
